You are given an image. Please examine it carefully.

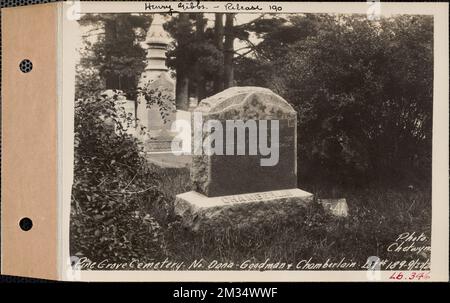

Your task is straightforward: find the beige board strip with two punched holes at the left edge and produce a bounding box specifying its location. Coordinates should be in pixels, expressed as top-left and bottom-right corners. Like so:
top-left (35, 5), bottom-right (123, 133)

top-left (1, 4), bottom-right (58, 279)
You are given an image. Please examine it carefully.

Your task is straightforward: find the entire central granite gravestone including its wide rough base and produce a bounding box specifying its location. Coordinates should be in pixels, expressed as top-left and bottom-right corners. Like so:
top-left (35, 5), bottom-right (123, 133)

top-left (175, 87), bottom-right (313, 229)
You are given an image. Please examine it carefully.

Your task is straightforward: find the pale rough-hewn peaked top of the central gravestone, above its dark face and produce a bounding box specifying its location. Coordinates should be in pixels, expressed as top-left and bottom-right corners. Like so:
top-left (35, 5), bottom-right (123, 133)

top-left (195, 86), bottom-right (296, 120)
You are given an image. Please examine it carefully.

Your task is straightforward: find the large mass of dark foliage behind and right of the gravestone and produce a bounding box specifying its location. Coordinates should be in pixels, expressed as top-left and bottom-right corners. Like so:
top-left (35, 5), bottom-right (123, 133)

top-left (236, 15), bottom-right (433, 190)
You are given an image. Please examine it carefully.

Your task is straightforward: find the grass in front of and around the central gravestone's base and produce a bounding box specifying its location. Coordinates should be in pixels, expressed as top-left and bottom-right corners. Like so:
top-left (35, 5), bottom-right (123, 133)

top-left (149, 166), bottom-right (431, 270)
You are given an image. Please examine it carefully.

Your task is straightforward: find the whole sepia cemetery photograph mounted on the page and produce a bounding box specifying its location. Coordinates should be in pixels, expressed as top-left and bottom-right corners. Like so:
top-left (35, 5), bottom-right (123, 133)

top-left (59, 1), bottom-right (448, 281)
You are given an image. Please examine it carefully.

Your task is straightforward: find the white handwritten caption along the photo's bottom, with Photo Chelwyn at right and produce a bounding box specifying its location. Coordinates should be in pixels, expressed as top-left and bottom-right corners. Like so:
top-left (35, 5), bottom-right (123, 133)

top-left (72, 232), bottom-right (431, 281)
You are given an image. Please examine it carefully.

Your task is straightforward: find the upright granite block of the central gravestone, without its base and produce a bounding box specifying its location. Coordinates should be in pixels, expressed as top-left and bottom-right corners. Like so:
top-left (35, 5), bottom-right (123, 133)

top-left (191, 87), bottom-right (297, 197)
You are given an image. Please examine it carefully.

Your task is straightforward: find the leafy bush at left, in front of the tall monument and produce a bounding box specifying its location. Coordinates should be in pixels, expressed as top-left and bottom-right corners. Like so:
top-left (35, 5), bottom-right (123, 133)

top-left (70, 91), bottom-right (169, 261)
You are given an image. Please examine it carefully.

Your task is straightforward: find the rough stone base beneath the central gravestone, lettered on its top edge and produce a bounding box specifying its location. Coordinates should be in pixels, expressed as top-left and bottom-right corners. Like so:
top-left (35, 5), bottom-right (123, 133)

top-left (174, 188), bottom-right (313, 231)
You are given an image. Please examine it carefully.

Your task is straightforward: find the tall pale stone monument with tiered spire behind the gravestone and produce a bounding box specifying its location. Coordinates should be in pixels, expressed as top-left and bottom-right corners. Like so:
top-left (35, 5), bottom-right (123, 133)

top-left (136, 14), bottom-right (175, 146)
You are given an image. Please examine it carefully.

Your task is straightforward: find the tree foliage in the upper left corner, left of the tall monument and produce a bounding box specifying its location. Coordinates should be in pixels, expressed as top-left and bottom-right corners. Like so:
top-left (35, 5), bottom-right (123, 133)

top-left (75, 14), bottom-right (151, 99)
